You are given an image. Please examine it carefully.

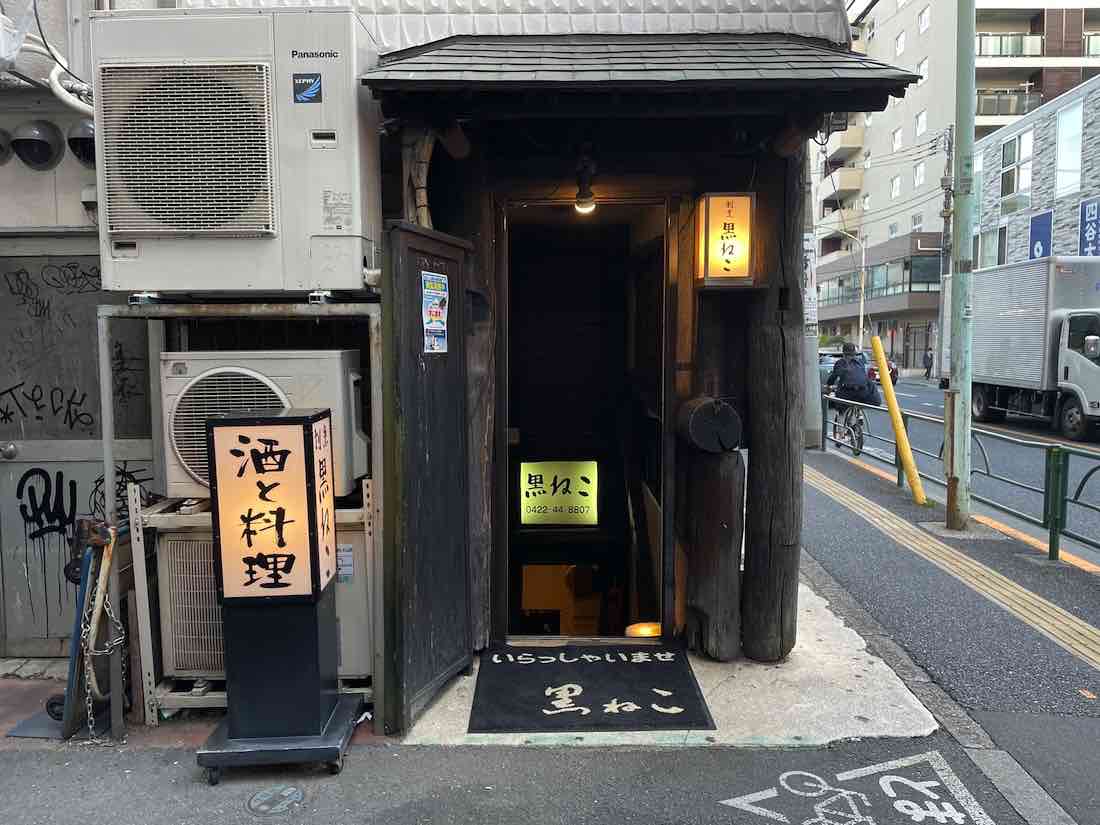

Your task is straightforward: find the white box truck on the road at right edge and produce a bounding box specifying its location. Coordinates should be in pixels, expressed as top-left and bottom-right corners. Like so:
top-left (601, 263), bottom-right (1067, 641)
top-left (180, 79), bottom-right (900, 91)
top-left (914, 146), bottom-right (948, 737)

top-left (972, 257), bottom-right (1100, 440)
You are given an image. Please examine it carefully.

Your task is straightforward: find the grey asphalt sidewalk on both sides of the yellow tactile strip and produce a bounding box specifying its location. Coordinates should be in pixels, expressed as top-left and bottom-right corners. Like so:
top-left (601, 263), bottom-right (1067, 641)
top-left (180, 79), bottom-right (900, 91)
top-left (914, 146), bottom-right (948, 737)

top-left (803, 453), bottom-right (1100, 825)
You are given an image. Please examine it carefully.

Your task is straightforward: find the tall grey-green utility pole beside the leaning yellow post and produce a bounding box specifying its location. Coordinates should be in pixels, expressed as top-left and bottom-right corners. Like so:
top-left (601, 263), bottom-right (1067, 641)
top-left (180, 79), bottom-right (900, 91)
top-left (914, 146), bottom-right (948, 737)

top-left (945, 0), bottom-right (977, 530)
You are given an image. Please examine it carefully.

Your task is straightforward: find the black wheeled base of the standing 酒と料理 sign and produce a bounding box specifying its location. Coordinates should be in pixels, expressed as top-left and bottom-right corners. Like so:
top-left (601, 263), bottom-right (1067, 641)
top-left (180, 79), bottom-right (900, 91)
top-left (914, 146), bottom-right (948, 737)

top-left (196, 693), bottom-right (363, 785)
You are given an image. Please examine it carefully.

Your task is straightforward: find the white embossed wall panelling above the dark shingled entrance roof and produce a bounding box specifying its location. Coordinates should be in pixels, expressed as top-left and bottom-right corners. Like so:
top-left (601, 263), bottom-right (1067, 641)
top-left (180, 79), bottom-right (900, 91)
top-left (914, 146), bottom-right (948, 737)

top-left (178, 0), bottom-right (851, 53)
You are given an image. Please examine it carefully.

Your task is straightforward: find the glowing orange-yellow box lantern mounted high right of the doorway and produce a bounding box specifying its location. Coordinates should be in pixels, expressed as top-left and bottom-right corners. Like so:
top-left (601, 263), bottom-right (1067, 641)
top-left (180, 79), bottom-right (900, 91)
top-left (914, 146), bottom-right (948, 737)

top-left (695, 195), bottom-right (754, 284)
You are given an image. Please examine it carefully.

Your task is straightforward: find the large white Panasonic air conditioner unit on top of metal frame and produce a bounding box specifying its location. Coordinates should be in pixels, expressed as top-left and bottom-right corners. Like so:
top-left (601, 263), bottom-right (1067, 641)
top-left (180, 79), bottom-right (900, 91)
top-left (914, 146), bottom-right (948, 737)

top-left (91, 8), bottom-right (382, 294)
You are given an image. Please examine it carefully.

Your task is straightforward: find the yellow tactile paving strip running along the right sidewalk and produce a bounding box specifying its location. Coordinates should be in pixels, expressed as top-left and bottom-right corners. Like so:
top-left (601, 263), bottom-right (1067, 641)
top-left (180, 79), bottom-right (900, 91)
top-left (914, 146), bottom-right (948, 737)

top-left (804, 466), bottom-right (1100, 670)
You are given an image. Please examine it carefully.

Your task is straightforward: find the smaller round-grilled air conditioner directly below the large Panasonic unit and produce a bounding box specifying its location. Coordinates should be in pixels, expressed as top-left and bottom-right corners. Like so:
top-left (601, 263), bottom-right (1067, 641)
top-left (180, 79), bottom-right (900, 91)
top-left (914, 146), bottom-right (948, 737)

top-left (161, 350), bottom-right (367, 498)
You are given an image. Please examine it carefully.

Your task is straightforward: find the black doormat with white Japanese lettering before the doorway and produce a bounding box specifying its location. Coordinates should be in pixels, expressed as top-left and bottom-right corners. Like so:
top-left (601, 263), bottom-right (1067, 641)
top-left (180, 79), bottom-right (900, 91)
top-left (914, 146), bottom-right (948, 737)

top-left (469, 645), bottom-right (714, 734)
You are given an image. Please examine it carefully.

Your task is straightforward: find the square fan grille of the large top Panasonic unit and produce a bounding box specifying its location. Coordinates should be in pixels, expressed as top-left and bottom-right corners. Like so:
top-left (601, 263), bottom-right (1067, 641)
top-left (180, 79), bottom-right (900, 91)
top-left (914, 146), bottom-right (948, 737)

top-left (96, 64), bottom-right (275, 237)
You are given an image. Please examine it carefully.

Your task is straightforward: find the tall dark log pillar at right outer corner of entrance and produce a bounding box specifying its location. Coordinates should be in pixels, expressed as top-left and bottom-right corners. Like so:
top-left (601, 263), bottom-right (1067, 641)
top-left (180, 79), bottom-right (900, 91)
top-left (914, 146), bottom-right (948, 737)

top-left (741, 149), bottom-right (805, 661)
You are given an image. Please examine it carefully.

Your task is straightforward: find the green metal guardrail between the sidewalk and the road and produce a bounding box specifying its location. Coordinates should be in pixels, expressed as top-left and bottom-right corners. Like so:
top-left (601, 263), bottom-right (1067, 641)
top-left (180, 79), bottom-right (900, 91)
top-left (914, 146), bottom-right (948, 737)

top-left (822, 395), bottom-right (1100, 561)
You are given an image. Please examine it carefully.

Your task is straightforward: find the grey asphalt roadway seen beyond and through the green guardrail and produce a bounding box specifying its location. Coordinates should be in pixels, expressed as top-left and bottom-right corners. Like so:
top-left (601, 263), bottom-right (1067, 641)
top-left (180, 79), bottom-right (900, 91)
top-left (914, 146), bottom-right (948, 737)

top-left (827, 378), bottom-right (1100, 556)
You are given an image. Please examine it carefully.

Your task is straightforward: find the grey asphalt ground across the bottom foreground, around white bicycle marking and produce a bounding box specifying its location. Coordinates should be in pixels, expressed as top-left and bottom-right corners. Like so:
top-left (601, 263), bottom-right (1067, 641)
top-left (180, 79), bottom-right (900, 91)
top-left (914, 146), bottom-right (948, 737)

top-left (0, 733), bottom-right (1020, 825)
